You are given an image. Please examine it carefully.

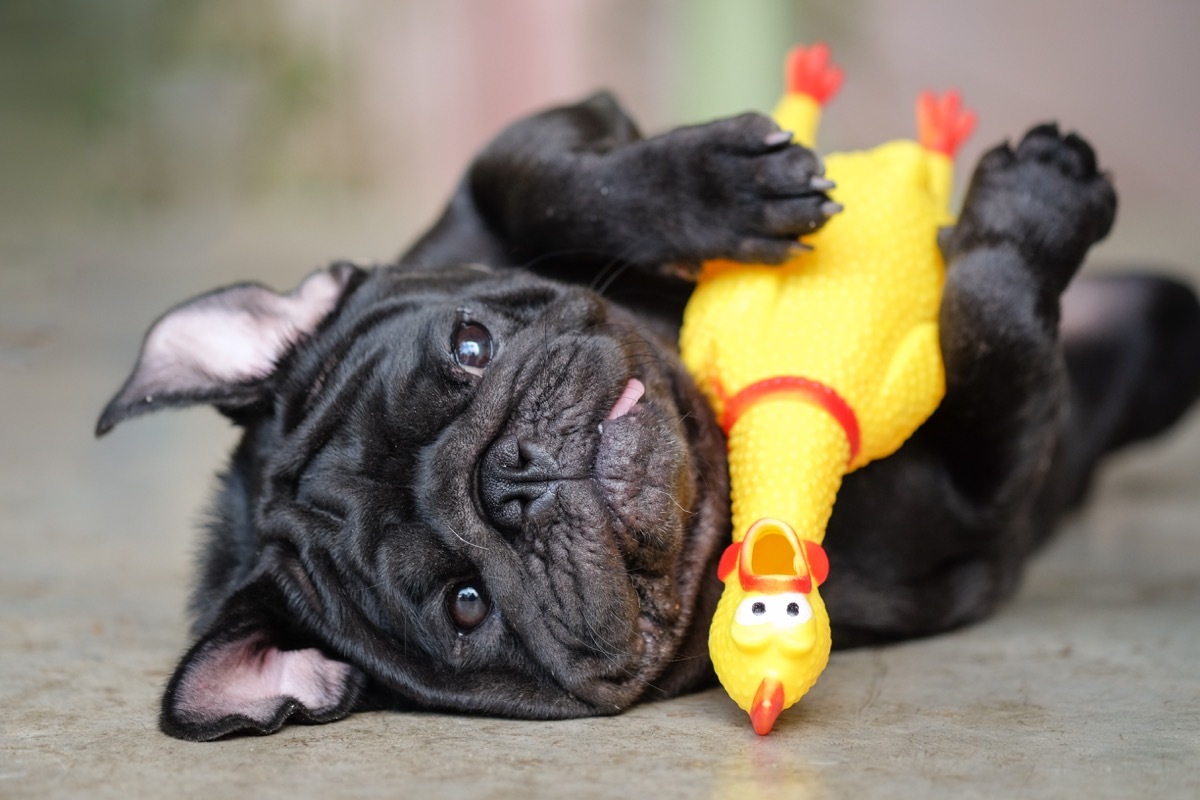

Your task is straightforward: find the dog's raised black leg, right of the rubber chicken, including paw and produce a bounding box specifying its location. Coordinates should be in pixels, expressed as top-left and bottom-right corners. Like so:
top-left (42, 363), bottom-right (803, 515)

top-left (923, 126), bottom-right (1116, 510)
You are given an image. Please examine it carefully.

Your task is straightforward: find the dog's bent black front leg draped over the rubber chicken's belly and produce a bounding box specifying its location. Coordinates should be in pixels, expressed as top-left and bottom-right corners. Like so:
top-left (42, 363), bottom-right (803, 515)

top-left (412, 94), bottom-right (838, 279)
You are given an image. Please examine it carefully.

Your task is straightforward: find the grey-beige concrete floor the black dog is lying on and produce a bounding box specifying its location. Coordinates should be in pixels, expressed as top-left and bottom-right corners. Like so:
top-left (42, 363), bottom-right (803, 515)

top-left (7, 201), bottom-right (1200, 798)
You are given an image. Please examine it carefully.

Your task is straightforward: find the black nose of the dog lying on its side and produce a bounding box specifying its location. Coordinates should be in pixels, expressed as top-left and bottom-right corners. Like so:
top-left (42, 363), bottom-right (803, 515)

top-left (479, 434), bottom-right (557, 533)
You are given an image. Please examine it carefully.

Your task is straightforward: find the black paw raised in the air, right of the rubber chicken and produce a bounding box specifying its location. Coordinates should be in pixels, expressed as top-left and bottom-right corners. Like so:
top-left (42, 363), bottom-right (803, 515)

top-left (946, 125), bottom-right (1117, 289)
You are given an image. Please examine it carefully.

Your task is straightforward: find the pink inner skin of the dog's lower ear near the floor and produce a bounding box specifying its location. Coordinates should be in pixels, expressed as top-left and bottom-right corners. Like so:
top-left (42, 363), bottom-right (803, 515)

top-left (175, 634), bottom-right (350, 724)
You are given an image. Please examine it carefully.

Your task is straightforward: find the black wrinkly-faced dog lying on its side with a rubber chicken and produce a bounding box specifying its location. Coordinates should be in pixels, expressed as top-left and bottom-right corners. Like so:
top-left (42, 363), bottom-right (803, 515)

top-left (98, 95), bottom-right (1200, 739)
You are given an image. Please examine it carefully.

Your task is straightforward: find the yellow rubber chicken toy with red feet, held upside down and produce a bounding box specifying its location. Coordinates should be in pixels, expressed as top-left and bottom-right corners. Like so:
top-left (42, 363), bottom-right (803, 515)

top-left (680, 44), bottom-right (974, 735)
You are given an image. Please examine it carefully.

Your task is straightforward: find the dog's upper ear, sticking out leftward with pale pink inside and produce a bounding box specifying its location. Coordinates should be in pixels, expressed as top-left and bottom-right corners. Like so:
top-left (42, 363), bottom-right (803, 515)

top-left (96, 263), bottom-right (361, 437)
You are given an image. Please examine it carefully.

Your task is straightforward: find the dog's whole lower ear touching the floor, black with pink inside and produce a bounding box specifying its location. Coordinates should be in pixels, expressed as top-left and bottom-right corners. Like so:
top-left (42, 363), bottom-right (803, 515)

top-left (158, 552), bottom-right (366, 741)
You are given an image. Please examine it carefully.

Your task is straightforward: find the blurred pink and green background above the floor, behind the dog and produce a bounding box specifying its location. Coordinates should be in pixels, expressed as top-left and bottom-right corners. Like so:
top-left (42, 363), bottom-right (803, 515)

top-left (7, 0), bottom-right (1200, 272)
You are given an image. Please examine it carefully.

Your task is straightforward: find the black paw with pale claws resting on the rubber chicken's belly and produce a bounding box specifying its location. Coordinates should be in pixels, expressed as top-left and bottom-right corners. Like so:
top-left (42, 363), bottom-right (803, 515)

top-left (660, 114), bottom-right (841, 264)
